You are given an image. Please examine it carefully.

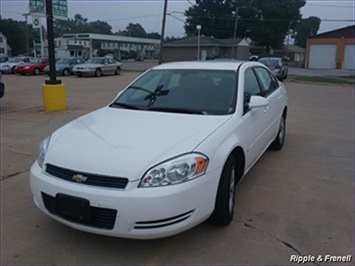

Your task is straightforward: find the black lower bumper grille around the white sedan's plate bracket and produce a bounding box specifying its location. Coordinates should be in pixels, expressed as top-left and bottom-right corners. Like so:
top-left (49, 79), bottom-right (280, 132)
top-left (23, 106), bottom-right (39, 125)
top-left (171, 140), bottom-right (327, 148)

top-left (42, 192), bottom-right (117, 229)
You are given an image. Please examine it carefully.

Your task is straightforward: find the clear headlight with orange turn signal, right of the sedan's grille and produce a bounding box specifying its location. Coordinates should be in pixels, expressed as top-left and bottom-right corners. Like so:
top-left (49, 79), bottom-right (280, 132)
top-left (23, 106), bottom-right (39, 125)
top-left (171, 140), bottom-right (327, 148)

top-left (138, 153), bottom-right (208, 188)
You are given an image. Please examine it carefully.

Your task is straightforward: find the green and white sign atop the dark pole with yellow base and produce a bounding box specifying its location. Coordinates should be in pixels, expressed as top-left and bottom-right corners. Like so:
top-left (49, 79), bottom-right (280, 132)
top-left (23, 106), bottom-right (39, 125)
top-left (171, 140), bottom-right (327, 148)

top-left (29, 0), bottom-right (68, 20)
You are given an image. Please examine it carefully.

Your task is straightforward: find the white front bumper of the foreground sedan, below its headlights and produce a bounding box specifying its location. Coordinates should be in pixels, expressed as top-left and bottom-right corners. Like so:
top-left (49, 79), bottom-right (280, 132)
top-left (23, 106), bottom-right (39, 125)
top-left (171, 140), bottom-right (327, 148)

top-left (30, 162), bottom-right (222, 239)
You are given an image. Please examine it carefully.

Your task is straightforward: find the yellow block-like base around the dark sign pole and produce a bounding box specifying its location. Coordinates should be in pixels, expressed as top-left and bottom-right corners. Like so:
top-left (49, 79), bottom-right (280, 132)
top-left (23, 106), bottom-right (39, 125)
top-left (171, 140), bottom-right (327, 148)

top-left (42, 83), bottom-right (67, 112)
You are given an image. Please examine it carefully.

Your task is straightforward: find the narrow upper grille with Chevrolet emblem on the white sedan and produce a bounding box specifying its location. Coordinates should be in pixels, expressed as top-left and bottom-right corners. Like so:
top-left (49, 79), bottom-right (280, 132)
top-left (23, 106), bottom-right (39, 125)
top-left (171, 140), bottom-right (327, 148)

top-left (46, 164), bottom-right (128, 189)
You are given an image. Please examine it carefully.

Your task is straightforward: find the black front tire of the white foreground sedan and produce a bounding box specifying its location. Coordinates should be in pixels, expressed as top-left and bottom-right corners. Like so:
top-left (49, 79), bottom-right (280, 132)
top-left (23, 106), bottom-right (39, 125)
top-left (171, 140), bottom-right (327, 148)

top-left (209, 155), bottom-right (237, 226)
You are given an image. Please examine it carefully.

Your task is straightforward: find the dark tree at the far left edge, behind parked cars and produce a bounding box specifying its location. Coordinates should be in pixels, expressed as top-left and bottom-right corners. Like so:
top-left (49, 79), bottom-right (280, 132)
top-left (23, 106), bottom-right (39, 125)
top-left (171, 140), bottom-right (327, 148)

top-left (0, 18), bottom-right (33, 55)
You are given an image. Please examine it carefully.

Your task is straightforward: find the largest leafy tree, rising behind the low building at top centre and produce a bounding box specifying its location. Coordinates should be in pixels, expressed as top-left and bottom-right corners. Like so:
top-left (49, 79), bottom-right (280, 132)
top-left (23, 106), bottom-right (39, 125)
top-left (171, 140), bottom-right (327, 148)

top-left (185, 0), bottom-right (306, 49)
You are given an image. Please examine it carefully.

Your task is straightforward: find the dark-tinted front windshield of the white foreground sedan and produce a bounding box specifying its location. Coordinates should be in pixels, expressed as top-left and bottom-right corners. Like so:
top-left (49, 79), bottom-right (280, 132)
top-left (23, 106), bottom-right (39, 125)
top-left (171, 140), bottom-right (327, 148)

top-left (111, 69), bottom-right (237, 115)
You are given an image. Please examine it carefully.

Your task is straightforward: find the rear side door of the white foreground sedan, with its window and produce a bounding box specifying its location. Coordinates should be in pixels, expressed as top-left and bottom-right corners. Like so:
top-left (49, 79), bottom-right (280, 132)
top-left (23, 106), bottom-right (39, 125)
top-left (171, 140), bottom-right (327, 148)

top-left (254, 67), bottom-right (283, 146)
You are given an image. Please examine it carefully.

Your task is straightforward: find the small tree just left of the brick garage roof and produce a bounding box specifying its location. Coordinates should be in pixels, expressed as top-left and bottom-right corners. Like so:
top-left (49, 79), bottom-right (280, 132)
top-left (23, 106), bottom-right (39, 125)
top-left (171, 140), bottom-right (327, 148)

top-left (292, 17), bottom-right (321, 48)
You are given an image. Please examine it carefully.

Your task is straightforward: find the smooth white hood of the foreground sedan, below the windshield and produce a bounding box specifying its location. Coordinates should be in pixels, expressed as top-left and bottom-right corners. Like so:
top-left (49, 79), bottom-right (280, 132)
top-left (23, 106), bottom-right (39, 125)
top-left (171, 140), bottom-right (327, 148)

top-left (45, 107), bottom-right (231, 181)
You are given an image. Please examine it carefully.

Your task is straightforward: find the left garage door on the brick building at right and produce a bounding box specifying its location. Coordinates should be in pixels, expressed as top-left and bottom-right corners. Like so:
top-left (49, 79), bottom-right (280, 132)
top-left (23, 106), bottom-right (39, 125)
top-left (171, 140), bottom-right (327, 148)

top-left (308, 44), bottom-right (337, 69)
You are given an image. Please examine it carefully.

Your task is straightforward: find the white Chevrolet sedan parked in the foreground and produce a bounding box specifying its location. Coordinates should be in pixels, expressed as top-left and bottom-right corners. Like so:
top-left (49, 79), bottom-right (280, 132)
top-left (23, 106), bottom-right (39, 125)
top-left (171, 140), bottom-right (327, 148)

top-left (30, 62), bottom-right (287, 239)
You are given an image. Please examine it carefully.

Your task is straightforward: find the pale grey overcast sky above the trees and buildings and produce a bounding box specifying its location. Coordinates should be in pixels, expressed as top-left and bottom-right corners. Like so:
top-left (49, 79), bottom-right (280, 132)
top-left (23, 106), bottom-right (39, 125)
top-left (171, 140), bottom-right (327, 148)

top-left (0, 0), bottom-right (354, 37)
